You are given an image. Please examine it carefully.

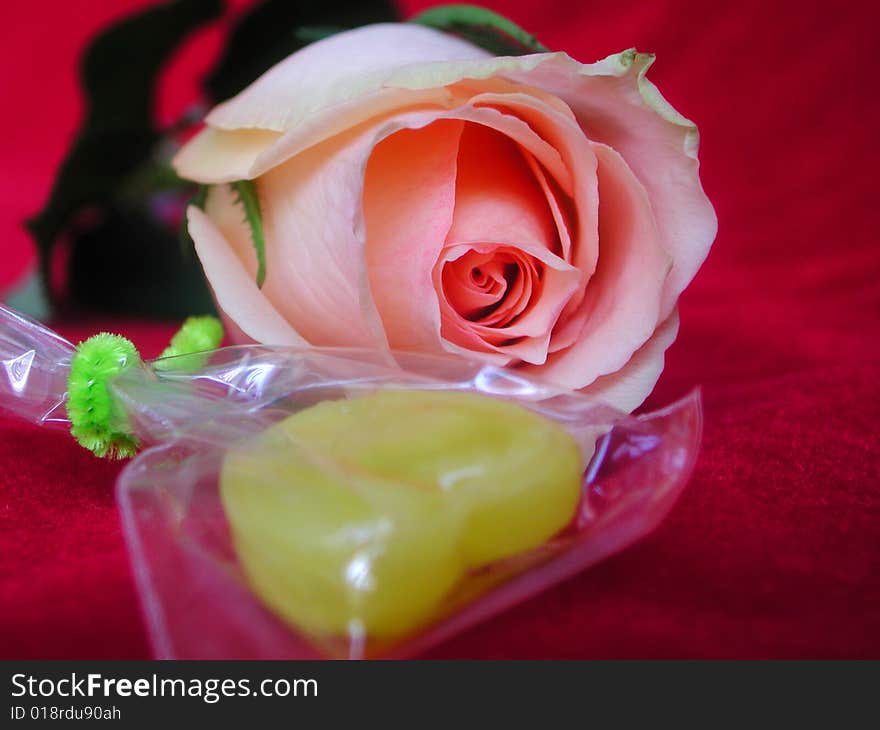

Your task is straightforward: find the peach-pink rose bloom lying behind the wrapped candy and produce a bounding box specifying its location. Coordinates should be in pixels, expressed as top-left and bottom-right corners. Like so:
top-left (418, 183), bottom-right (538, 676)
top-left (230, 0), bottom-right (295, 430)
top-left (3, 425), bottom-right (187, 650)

top-left (175, 24), bottom-right (717, 411)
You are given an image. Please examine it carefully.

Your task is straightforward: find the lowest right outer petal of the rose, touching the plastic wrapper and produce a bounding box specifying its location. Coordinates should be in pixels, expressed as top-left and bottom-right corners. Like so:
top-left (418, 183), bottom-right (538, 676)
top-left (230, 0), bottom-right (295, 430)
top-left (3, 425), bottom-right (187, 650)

top-left (581, 309), bottom-right (678, 413)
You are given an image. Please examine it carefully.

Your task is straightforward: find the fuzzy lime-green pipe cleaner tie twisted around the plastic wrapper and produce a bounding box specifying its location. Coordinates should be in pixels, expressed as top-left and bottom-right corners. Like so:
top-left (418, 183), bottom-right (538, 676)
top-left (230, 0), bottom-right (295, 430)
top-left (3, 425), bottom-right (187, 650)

top-left (67, 317), bottom-right (223, 459)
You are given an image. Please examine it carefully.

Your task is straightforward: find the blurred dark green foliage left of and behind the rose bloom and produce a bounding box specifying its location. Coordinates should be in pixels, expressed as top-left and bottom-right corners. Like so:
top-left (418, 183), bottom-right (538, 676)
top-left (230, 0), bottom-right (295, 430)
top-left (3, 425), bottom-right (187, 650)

top-left (27, 0), bottom-right (396, 317)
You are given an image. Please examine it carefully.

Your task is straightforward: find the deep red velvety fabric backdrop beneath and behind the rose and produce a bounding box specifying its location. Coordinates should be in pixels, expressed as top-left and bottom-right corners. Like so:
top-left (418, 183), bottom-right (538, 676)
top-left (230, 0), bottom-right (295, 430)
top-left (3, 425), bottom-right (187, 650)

top-left (0, 0), bottom-right (880, 658)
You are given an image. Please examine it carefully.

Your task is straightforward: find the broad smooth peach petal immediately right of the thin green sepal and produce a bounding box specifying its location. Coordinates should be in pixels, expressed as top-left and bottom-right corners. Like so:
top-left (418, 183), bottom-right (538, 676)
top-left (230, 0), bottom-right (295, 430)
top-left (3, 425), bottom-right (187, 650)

top-left (257, 128), bottom-right (394, 349)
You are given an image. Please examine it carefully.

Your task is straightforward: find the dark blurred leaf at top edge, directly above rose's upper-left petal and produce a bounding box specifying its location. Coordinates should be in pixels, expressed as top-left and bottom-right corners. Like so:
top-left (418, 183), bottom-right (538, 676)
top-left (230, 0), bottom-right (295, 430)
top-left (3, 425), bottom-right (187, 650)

top-left (205, 0), bottom-right (400, 102)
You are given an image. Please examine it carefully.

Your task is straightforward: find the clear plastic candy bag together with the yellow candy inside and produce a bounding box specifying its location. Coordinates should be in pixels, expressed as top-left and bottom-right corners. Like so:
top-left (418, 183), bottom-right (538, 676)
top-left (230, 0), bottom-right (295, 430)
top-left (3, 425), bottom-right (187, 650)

top-left (0, 304), bottom-right (701, 658)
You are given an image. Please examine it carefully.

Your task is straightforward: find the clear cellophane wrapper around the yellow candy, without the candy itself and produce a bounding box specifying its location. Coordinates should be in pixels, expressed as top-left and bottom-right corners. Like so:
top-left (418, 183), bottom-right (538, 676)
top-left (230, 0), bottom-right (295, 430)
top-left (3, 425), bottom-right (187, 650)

top-left (0, 308), bottom-right (702, 659)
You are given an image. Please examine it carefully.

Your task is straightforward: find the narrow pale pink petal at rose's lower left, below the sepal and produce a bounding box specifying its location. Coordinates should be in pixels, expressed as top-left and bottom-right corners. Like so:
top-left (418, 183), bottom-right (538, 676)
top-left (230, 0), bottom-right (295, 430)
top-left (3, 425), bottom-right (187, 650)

top-left (187, 206), bottom-right (304, 345)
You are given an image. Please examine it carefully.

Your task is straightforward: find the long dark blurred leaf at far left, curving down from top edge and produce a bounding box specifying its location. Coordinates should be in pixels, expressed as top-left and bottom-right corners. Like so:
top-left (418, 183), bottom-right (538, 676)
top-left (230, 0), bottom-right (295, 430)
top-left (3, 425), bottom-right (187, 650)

top-left (27, 0), bottom-right (222, 298)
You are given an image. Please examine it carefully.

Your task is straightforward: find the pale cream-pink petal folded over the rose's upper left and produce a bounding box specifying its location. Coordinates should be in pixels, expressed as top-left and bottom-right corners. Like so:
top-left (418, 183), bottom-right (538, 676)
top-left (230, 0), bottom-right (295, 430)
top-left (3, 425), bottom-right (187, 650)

top-left (174, 23), bottom-right (491, 183)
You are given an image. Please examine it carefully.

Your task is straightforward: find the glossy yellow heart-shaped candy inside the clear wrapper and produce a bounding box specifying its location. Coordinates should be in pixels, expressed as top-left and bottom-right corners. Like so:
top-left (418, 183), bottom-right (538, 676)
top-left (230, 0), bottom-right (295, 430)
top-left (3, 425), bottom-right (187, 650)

top-left (220, 390), bottom-right (582, 638)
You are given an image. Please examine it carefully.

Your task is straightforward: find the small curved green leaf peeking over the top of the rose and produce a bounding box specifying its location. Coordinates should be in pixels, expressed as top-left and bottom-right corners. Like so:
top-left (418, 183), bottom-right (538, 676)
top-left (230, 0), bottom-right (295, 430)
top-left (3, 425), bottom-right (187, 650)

top-left (410, 4), bottom-right (550, 56)
